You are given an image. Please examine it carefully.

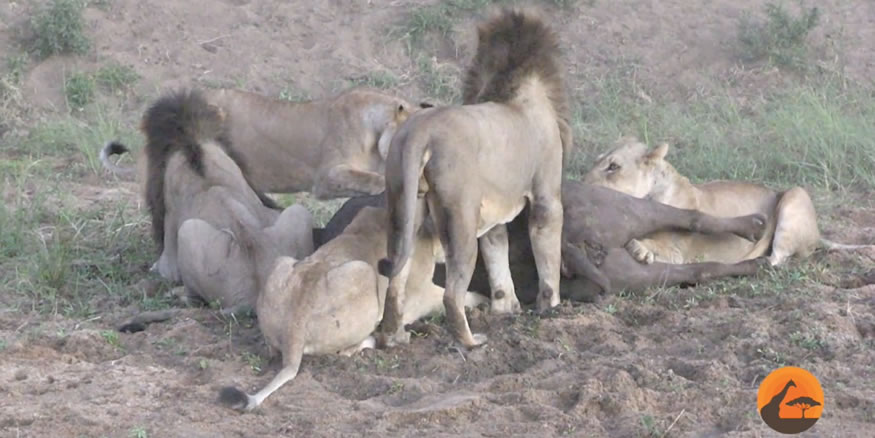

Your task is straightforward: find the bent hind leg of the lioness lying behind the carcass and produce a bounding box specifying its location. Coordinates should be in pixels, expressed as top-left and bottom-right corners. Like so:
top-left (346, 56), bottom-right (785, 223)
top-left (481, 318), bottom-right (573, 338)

top-left (769, 187), bottom-right (820, 266)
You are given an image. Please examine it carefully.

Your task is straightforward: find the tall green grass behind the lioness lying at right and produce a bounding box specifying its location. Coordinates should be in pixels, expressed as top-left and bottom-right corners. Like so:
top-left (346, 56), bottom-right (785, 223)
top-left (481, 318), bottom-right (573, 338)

top-left (568, 73), bottom-right (875, 190)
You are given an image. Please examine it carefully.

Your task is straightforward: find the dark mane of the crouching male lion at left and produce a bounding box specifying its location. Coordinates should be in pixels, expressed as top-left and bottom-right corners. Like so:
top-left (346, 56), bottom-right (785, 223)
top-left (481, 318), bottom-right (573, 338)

top-left (140, 90), bottom-right (277, 253)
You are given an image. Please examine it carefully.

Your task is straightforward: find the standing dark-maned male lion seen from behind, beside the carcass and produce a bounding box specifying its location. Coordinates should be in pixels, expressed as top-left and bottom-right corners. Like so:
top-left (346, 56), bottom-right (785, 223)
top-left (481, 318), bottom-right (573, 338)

top-left (380, 9), bottom-right (572, 348)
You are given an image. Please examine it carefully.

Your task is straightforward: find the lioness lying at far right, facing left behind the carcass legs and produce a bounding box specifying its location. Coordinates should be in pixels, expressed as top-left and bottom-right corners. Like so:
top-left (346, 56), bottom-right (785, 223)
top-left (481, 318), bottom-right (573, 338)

top-left (584, 137), bottom-right (875, 266)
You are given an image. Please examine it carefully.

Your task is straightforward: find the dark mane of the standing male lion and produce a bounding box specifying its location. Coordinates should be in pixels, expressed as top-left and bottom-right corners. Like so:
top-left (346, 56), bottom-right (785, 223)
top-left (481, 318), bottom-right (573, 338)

top-left (462, 8), bottom-right (572, 164)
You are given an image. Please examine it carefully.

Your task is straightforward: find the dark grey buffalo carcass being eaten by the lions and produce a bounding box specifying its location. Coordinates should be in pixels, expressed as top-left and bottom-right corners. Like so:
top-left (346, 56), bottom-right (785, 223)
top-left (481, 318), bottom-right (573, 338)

top-left (317, 180), bottom-right (766, 304)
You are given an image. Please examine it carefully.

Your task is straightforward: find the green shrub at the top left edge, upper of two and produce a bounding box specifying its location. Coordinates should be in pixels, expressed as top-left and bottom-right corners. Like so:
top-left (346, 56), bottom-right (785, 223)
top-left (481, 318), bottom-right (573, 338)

top-left (31, 0), bottom-right (91, 58)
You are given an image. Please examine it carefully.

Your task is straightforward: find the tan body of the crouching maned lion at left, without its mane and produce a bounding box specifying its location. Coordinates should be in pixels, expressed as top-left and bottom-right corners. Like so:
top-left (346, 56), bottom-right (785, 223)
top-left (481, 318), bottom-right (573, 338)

top-left (156, 142), bottom-right (313, 308)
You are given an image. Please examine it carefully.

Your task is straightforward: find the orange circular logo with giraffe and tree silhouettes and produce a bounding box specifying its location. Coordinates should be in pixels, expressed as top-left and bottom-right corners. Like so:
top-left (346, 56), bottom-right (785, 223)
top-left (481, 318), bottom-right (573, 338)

top-left (757, 367), bottom-right (824, 434)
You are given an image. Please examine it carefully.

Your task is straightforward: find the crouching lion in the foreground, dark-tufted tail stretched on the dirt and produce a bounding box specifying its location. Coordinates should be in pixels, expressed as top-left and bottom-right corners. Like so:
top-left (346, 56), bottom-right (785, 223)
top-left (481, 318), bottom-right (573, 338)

top-left (219, 206), bottom-right (485, 410)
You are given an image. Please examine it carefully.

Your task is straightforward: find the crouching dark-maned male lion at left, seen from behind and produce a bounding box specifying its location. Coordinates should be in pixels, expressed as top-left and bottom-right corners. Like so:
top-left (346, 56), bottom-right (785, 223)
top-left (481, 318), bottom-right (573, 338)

top-left (103, 90), bottom-right (313, 309)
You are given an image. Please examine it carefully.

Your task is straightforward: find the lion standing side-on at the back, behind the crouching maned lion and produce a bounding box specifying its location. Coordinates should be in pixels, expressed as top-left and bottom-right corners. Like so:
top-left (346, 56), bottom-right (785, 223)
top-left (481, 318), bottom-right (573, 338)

top-left (100, 87), bottom-right (431, 200)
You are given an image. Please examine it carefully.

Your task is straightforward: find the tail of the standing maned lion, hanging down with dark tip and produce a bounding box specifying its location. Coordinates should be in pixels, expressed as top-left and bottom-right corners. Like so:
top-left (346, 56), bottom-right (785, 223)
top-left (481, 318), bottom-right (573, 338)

top-left (377, 135), bottom-right (431, 278)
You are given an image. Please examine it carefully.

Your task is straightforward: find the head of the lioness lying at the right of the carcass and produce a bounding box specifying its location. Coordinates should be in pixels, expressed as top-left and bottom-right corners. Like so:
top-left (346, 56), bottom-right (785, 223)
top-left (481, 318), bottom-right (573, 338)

top-left (583, 137), bottom-right (668, 198)
